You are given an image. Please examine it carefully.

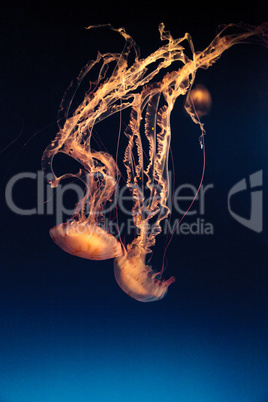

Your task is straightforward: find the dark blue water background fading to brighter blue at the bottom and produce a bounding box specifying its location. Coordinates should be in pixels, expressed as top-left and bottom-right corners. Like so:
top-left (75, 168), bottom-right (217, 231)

top-left (0, 1), bottom-right (268, 402)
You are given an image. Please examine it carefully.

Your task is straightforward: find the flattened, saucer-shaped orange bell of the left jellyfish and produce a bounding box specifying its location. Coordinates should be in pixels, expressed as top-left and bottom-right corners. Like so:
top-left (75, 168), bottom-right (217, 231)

top-left (49, 222), bottom-right (123, 260)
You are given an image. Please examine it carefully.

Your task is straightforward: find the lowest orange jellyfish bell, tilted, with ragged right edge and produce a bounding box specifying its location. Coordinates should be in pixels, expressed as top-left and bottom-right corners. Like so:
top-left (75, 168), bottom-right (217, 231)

top-left (114, 252), bottom-right (175, 302)
